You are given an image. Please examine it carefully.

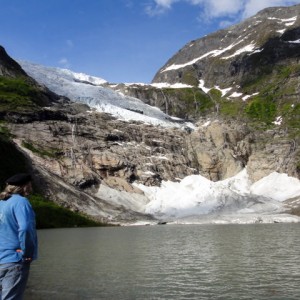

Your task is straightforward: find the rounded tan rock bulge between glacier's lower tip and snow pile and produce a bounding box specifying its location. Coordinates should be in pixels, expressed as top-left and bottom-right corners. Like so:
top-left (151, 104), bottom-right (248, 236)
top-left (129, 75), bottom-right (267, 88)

top-left (188, 121), bottom-right (252, 181)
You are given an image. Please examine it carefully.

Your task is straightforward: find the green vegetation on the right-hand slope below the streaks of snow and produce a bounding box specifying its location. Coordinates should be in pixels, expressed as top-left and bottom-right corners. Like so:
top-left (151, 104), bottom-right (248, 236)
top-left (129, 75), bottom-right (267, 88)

top-left (195, 65), bottom-right (300, 131)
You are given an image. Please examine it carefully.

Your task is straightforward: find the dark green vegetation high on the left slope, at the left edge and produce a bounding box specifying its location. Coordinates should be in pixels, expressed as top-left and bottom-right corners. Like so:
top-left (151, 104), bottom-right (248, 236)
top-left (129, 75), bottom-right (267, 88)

top-left (0, 76), bottom-right (42, 112)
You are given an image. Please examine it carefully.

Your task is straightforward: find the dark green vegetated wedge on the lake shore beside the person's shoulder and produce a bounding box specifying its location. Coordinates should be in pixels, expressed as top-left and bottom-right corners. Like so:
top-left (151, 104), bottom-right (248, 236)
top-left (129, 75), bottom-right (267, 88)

top-left (30, 195), bottom-right (107, 229)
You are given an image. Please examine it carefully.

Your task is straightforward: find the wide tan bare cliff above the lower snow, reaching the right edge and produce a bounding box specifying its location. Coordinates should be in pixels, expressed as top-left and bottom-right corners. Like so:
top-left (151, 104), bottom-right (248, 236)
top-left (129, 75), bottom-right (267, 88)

top-left (187, 121), bottom-right (300, 182)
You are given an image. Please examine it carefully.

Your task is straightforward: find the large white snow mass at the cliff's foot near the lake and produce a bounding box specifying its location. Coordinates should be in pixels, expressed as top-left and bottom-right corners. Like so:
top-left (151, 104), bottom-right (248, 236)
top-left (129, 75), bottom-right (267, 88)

top-left (137, 169), bottom-right (300, 220)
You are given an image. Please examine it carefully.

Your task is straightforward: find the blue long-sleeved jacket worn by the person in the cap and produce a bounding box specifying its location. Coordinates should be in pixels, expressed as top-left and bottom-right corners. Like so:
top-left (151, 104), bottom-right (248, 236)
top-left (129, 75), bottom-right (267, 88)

top-left (0, 194), bottom-right (37, 264)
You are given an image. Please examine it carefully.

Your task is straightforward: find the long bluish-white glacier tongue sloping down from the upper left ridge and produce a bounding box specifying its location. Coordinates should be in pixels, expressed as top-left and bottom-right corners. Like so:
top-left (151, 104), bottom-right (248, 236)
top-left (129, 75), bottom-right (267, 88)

top-left (19, 61), bottom-right (190, 127)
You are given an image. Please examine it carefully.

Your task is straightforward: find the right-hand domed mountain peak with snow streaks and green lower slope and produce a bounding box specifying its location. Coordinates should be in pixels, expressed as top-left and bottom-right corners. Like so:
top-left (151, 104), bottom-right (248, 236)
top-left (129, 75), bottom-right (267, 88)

top-left (153, 5), bottom-right (300, 130)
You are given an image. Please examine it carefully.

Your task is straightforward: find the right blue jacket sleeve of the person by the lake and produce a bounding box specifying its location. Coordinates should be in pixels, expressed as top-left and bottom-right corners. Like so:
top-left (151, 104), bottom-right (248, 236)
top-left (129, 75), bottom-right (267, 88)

top-left (15, 198), bottom-right (37, 259)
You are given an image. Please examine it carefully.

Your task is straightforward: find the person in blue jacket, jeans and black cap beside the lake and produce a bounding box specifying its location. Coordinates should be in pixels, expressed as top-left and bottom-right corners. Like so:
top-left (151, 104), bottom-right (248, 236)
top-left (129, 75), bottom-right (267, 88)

top-left (0, 173), bottom-right (37, 300)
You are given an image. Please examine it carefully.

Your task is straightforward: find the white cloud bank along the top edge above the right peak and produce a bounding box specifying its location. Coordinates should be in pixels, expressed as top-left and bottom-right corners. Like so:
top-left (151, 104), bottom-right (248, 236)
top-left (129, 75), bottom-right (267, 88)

top-left (146, 0), bottom-right (300, 22)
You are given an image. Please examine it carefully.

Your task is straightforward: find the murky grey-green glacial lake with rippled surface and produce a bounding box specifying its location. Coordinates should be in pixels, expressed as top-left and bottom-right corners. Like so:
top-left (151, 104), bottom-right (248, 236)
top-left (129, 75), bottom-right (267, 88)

top-left (25, 224), bottom-right (300, 300)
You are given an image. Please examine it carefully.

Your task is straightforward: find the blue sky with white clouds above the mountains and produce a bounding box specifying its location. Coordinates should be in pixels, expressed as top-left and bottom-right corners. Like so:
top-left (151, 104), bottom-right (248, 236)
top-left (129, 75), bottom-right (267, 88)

top-left (0, 0), bottom-right (300, 83)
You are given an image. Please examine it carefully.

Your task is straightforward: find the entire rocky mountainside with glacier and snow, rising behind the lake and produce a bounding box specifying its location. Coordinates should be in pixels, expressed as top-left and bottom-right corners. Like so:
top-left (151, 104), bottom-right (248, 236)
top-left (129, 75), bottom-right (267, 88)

top-left (0, 6), bottom-right (300, 223)
